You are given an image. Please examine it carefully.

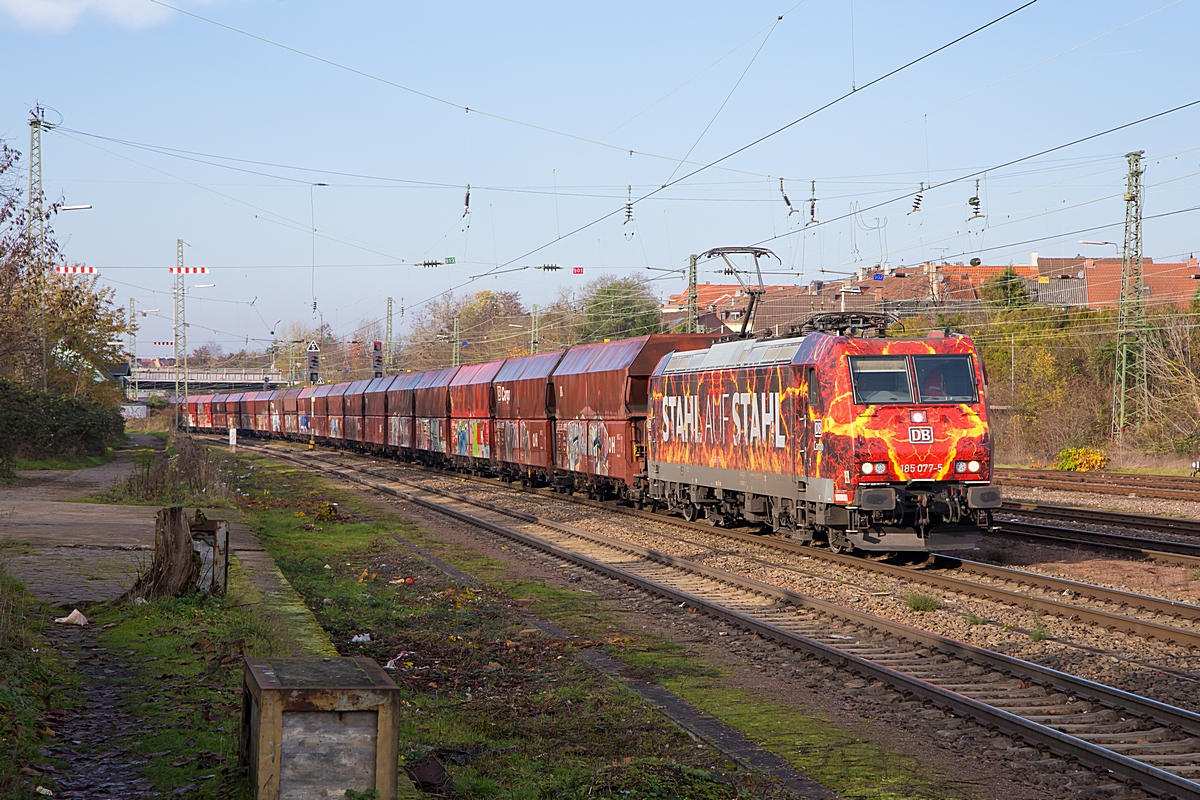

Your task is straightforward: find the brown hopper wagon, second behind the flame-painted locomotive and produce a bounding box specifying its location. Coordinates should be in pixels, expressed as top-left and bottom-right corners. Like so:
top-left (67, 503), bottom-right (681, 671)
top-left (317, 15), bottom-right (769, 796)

top-left (492, 350), bottom-right (565, 476)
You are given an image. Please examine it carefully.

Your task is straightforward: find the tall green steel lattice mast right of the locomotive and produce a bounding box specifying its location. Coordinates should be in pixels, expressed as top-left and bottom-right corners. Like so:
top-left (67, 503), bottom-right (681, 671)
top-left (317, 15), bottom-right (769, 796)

top-left (1110, 150), bottom-right (1150, 441)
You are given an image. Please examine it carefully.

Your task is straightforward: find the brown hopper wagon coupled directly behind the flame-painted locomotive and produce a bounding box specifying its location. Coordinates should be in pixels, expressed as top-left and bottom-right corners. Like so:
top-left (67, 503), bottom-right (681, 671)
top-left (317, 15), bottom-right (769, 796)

top-left (552, 333), bottom-right (716, 499)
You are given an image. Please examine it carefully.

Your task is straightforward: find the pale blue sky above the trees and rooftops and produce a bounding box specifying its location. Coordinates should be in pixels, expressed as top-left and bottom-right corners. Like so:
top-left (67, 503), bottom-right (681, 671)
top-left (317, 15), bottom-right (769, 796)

top-left (0, 0), bottom-right (1200, 357)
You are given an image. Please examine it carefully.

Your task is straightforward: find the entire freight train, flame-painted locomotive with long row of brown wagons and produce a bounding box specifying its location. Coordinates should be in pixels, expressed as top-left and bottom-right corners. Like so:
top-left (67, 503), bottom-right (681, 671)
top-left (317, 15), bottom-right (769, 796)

top-left (185, 320), bottom-right (1001, 552)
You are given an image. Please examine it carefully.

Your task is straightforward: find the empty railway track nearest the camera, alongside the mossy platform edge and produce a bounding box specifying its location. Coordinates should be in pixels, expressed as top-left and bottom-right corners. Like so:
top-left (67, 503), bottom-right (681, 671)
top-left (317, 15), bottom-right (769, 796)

top-left (238, 441), bottom-right (1200, 799)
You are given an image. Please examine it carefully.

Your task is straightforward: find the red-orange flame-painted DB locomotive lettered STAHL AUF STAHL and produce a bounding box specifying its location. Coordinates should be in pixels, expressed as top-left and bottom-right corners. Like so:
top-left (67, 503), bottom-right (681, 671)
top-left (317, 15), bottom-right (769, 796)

top-left (647, 332), bottom-right (1000, 551)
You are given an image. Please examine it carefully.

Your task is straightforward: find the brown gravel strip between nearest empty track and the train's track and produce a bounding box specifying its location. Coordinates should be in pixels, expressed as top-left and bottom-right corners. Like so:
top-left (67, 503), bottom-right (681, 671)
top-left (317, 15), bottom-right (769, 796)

top-left (348, 464), bottom-right (1200, 710)
